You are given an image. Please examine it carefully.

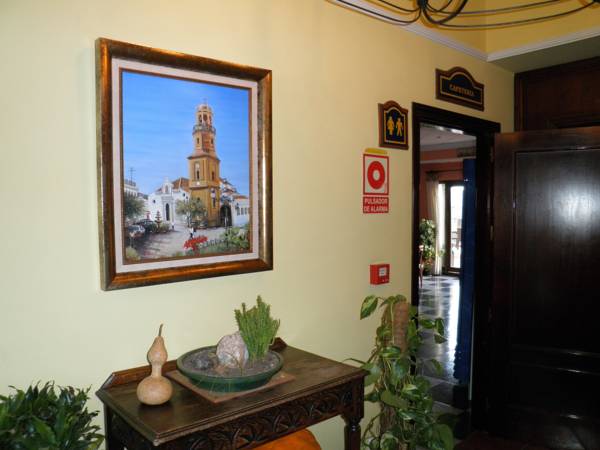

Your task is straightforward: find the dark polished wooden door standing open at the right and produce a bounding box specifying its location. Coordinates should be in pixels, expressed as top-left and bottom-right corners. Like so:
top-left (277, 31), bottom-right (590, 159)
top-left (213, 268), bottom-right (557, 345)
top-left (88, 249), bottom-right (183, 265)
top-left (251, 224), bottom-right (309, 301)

top-left (489, 127), bottom-right (600, 449)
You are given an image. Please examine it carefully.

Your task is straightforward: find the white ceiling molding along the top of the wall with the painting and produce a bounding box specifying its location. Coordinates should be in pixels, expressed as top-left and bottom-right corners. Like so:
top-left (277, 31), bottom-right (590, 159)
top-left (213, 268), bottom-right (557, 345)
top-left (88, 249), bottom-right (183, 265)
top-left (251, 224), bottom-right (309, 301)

top-left (327, 0), bottom-right (488, 61)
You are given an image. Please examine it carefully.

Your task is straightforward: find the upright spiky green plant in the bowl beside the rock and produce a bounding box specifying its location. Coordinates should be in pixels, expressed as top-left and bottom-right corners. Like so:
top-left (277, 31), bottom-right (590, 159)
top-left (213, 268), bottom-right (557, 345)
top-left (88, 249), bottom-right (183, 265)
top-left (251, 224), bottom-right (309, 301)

top-left (235, 295), bottom-right (279, 360)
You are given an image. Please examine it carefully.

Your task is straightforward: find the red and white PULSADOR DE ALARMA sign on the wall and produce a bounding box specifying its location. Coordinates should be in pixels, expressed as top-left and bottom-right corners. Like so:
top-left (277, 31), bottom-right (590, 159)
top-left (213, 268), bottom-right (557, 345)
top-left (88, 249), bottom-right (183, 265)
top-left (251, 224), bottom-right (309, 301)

top-left (363, 149), bottom-right (389, 214)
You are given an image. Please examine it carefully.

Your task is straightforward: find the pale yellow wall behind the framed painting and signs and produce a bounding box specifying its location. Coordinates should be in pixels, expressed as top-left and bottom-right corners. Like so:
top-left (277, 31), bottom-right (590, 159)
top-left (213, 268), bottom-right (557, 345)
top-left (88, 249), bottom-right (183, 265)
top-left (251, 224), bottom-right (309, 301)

top-left (0, 0), bottom-right (512, 450)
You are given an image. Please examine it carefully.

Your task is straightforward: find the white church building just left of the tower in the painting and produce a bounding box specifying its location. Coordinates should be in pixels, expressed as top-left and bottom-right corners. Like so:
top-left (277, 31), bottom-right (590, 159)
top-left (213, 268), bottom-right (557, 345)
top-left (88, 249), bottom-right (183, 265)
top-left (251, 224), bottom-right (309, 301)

top-left (146, 178), bottom-right (190, 226)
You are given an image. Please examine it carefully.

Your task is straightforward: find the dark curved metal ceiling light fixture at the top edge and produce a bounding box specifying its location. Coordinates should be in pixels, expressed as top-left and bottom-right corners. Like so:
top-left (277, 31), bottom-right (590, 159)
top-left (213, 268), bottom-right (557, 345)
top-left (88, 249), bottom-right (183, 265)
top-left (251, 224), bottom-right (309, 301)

top-left (336, 0), bottom-right (600, 29)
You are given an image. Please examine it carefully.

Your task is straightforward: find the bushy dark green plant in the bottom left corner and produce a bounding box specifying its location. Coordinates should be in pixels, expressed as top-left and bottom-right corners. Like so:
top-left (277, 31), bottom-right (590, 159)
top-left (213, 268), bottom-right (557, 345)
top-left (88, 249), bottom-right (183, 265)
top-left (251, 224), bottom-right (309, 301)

top-left (0, 382), bottom-right (103, 450)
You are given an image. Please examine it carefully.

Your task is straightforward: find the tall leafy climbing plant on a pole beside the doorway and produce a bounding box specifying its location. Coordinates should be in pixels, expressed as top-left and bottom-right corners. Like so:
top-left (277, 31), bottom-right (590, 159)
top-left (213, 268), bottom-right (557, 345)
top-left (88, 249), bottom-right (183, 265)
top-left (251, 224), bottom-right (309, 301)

top-left (353, 295), bottom-right (454, 450)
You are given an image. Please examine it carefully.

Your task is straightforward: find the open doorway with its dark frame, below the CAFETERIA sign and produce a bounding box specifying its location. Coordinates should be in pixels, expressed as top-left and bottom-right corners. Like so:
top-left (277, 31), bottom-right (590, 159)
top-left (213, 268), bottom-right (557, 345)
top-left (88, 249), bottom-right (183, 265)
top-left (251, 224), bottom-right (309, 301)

top-left (412, 103), bottom-right (500, 434)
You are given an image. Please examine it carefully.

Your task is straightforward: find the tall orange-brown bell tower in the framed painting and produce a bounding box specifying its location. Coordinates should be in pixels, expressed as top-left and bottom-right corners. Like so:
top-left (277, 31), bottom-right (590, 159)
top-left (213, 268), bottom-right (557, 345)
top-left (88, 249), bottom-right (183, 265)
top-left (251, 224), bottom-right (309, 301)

top-left (188, 102), bottom-right (221, 227)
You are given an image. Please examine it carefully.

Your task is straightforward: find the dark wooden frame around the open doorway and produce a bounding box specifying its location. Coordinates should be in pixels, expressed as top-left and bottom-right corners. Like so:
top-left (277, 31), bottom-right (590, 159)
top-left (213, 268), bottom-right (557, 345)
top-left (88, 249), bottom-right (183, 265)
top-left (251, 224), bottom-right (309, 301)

top-left (411, 102), bottom-right (500, 429)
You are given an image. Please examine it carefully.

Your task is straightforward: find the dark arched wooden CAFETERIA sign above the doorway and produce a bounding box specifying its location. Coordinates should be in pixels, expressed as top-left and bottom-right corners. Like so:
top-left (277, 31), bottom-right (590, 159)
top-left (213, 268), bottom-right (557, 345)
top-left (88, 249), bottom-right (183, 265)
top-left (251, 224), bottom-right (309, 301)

top-left (435, 67), bottom-right (484, 111)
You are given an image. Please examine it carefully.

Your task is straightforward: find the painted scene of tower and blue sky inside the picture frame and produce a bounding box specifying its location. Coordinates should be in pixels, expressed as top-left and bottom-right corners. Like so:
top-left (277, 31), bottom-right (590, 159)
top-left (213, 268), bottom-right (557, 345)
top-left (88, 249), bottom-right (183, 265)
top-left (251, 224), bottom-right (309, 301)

top-left (122, 70), bottom-right (252, 264)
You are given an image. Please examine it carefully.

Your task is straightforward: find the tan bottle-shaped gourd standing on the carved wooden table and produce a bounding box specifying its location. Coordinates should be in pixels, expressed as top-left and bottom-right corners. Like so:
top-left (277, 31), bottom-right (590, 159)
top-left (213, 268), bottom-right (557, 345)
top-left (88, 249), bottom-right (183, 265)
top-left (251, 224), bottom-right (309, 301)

top-left (136, 324), bottom-right (173, 405)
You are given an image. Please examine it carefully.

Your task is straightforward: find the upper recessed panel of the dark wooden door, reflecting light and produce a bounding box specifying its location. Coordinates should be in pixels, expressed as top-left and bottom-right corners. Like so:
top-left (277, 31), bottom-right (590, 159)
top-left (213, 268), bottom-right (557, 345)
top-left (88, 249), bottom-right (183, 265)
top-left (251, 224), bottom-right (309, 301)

top-left (511, 149), bottom-right (600, 353)
